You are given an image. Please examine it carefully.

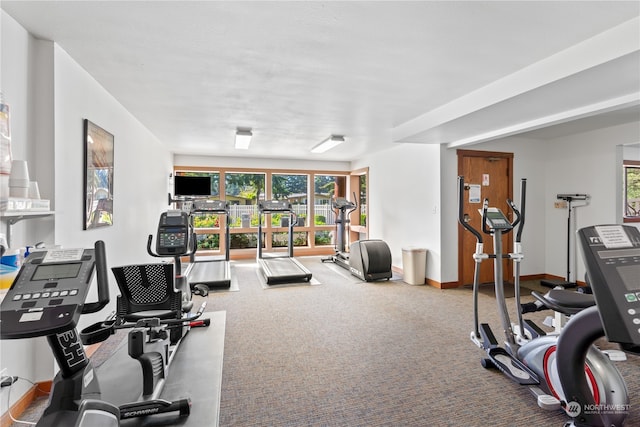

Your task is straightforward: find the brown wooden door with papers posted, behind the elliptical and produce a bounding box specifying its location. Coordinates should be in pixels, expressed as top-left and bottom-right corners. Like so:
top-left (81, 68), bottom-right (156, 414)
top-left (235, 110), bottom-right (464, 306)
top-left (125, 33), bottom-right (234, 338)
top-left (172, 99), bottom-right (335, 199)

top-left (457, 150), bottom-right (513, 285)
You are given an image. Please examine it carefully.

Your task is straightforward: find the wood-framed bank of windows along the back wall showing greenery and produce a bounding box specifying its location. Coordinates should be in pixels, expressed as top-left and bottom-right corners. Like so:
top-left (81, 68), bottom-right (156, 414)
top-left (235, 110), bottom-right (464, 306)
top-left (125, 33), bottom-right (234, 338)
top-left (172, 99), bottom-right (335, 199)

top-left (174, 166), bottom-right (367, 259)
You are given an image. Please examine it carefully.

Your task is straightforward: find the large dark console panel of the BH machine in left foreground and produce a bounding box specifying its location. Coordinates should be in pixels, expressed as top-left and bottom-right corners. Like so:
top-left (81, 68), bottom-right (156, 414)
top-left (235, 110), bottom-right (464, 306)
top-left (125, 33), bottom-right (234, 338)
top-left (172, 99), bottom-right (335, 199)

top-left (0, 249), bottom-right (96, 339)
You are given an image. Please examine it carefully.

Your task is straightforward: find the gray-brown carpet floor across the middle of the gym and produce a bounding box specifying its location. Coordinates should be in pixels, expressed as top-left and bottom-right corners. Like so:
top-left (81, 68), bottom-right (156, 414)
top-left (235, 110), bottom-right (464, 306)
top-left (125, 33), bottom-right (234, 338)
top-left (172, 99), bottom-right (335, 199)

top-left (6, 257), bottom-right (640, 427)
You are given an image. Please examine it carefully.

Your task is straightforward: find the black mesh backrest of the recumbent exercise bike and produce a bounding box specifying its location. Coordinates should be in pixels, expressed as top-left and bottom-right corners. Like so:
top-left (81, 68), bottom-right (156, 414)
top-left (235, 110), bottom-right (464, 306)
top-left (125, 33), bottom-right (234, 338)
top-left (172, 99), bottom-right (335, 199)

top-left (111, 263), bottom-right (182, 321)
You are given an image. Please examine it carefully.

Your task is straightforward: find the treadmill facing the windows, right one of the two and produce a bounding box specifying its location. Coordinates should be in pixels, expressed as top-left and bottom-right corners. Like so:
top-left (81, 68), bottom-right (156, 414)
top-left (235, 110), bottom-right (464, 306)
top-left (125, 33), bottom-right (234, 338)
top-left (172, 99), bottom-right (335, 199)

top-left (257, 200), bottom-right (311, 285)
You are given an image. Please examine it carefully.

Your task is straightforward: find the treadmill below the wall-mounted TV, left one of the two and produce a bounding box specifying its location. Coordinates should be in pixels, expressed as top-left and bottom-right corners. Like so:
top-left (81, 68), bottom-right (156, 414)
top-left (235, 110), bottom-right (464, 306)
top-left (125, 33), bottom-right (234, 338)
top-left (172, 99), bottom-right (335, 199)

top-left (188, 199), bottom-right (231, 289)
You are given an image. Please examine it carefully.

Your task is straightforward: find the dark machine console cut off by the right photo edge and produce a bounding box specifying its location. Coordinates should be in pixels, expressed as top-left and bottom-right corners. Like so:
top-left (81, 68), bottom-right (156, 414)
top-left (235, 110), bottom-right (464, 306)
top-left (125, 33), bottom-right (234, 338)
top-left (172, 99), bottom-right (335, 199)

top-left (578, 225), bottom-right (640, 351)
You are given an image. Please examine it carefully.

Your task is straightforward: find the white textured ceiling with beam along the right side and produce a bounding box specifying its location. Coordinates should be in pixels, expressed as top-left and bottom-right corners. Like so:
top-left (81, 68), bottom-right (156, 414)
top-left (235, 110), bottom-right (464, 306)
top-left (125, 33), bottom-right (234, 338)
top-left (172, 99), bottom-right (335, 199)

top-left (0, 0), bottom-right (640, 160)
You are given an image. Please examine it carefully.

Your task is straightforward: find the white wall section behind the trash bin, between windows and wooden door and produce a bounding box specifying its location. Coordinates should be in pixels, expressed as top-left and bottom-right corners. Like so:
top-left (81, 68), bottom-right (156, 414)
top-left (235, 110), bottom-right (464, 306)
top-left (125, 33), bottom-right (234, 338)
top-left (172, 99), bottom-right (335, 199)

top-left (352, 144), bottom-right (441, 281)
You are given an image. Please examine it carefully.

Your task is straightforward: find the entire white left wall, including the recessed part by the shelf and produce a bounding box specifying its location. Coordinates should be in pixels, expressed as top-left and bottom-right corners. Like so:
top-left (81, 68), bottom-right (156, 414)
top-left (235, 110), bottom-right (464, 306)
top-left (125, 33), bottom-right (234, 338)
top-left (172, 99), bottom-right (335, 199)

top-left (0, 12), bottom-right (173, 413)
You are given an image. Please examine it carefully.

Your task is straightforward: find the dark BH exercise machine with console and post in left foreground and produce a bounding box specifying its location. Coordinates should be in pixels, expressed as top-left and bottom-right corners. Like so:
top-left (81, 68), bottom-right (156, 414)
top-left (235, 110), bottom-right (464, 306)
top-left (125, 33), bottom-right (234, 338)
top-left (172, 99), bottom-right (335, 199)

top-left (0, 241), bottom-right (120, 427)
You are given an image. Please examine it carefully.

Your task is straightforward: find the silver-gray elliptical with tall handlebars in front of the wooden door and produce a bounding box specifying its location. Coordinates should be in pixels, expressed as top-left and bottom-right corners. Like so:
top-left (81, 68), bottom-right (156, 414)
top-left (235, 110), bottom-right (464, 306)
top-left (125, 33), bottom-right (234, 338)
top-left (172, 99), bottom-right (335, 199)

top-left (458, 176), bottom-right (629, 426)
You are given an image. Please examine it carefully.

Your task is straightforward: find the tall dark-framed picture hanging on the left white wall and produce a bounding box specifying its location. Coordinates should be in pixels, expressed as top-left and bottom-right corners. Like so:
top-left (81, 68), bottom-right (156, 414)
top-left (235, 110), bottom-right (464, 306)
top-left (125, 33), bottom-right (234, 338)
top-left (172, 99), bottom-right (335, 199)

top-left (83, 119), bottom-right (113, 230)
